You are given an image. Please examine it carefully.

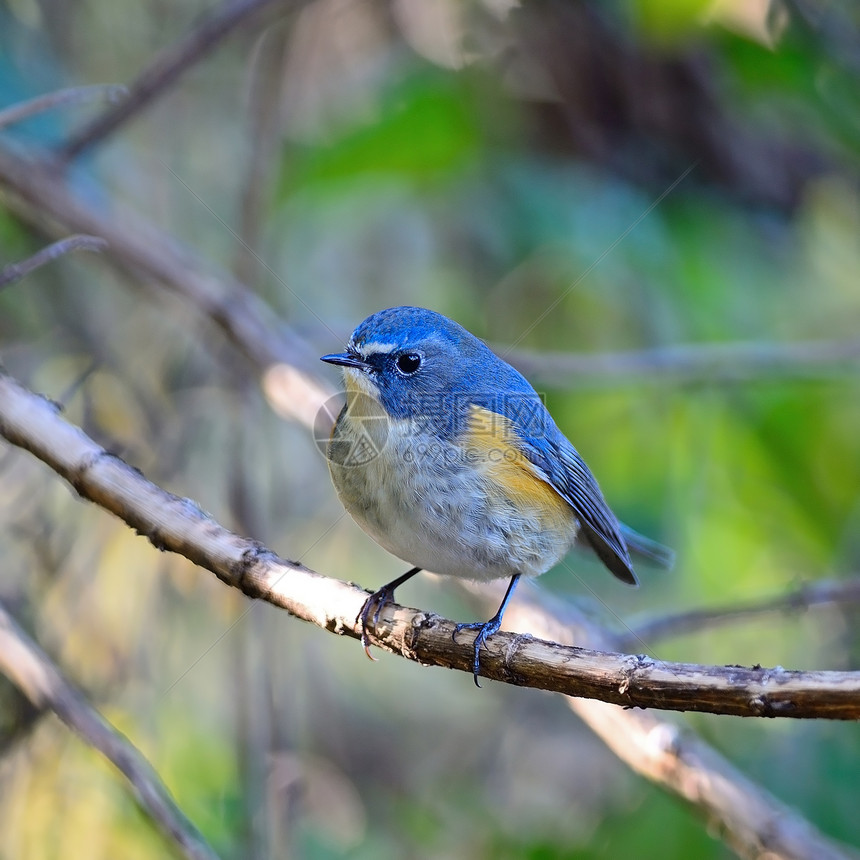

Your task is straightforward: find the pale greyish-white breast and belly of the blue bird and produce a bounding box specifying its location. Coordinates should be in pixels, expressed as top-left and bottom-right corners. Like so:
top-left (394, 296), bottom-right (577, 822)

top-left (329, 416), bottom-right (577, 580)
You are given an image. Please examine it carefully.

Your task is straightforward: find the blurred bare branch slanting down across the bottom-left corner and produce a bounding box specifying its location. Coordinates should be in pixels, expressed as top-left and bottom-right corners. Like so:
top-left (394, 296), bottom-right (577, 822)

top-left (0, 603), bottom-right (217, 860)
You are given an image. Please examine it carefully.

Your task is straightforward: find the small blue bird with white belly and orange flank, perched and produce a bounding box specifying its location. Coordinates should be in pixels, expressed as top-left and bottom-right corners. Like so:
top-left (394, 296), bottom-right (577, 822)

top-left (321, 306), bottom-right (674, 686)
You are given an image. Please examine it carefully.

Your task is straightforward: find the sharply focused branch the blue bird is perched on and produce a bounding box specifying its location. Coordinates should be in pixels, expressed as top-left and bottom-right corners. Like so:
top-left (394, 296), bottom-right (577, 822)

top-left (0, 366), bottom-right (860, 720)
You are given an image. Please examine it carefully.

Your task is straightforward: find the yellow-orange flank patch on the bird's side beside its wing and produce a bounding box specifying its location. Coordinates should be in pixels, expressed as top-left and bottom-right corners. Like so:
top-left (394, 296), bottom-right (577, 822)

top-left (464, 406), bottom-right (574, 527)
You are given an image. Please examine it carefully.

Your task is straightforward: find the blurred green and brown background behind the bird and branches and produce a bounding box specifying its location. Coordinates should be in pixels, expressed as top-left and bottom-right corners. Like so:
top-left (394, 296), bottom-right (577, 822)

top-left (0, 0), bottom-right (860, 860)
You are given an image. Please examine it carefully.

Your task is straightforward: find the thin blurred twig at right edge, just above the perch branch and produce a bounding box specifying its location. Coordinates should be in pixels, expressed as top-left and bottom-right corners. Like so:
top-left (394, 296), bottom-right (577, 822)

top-left (620, 579), bottom-right (860, 647)
